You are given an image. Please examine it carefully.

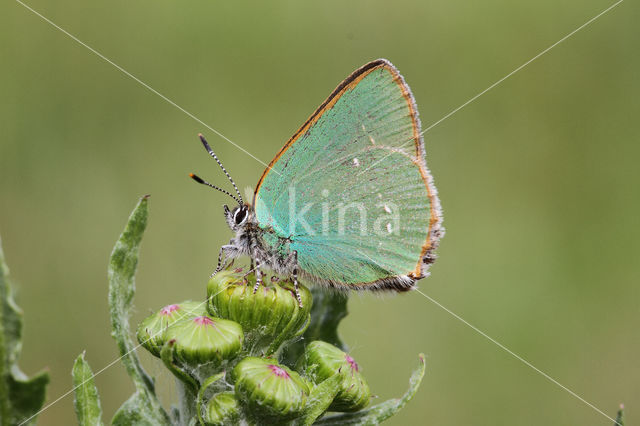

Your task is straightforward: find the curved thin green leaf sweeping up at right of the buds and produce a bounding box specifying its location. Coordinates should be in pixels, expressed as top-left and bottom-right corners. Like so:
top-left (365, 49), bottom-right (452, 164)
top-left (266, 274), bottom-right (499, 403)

top-left (315, 354), bottom-right (425, 425)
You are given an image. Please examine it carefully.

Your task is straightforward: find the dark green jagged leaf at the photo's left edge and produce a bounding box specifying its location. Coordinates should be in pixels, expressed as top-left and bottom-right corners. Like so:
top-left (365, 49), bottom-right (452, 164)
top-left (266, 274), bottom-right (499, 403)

top-left (0, 235), bottom-right (49, 426)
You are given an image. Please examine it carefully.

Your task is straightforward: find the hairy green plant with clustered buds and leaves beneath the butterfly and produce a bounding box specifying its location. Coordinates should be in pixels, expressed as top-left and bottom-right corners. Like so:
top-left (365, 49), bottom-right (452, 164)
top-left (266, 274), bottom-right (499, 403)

top-left (73, 197), bottom-right (425, 425)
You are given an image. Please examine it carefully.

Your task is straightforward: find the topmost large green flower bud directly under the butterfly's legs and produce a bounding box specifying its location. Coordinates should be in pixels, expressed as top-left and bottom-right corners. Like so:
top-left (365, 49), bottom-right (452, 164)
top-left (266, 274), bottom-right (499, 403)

top-left (207, 269), bottom-right (311, 354)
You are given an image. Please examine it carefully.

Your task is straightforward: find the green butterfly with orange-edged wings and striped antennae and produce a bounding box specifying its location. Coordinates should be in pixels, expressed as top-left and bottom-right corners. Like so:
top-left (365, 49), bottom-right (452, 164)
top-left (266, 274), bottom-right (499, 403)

top-left (190, 59), bottom-right (444, 305)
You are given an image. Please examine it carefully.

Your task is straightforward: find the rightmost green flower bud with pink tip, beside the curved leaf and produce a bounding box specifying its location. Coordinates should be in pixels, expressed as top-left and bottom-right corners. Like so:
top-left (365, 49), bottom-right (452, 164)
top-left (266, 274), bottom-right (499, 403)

top-left (297, 340), bottom-right (371, 412)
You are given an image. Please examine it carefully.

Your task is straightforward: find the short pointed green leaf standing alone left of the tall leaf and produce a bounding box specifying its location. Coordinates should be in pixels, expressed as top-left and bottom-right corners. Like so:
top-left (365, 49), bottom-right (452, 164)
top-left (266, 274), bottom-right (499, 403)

top-left (71, 352), bottom-right (103, 426)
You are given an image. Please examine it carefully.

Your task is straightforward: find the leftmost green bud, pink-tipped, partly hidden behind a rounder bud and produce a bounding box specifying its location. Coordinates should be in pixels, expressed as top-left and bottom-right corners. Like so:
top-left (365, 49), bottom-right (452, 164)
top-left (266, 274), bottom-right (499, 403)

top-left (136, 302), bottom-right (206, 357)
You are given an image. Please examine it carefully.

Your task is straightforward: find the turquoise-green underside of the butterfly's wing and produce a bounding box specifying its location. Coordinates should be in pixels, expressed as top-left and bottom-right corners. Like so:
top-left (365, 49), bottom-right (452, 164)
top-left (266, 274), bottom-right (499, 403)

top-left (255, 68), bottom-right (431, 284)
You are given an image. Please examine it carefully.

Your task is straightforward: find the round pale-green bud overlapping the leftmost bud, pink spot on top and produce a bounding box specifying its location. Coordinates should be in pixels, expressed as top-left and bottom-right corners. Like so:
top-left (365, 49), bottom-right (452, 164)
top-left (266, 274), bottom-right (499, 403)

top-left (166, 315), bottom-right (243, 367)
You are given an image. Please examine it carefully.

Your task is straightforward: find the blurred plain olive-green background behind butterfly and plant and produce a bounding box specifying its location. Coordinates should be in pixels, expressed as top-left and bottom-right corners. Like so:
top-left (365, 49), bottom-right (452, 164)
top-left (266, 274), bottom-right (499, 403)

top-left (0, 0), bottom-right (640, 425)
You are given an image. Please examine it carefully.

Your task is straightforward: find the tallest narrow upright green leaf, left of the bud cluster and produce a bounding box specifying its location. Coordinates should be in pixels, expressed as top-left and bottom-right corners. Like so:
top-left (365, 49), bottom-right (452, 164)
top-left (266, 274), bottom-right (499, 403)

top-left (108, 196), bottom-right (171, 425)
